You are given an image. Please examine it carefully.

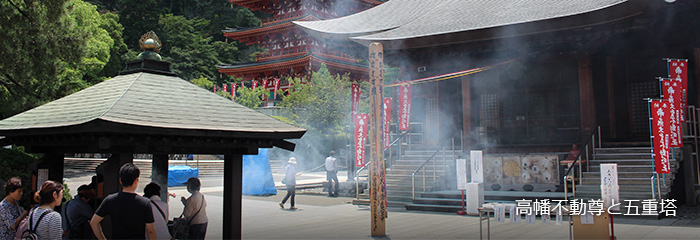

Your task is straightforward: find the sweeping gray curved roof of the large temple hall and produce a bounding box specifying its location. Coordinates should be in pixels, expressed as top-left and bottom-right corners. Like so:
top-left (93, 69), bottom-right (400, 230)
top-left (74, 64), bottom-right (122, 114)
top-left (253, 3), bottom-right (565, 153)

top-left (295, 0), bottom-right (642, 48)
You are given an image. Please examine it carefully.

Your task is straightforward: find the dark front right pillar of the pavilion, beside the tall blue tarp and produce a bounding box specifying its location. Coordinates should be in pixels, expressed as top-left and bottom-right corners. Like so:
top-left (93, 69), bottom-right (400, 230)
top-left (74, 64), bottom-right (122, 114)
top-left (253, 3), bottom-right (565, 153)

top-left (227, 153), bottom-right (243, 239)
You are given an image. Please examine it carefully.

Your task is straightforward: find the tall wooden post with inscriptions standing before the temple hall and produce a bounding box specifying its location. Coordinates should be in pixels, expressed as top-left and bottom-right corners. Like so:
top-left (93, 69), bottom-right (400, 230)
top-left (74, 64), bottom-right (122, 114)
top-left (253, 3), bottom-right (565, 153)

top-left (369, 43), bottom-right (387, 237)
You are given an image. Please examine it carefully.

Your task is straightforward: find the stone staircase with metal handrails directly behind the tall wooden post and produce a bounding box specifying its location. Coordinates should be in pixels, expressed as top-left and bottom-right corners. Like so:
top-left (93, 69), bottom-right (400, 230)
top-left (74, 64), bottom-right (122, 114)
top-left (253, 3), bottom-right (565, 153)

top-left (353, 149), bottom-right (455, 207)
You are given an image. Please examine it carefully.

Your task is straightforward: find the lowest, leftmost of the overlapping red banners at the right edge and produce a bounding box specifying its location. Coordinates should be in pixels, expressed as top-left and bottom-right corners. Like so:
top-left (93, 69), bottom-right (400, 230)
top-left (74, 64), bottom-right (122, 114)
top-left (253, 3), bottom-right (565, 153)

top-left (649, 100), bottom-right (671, 173)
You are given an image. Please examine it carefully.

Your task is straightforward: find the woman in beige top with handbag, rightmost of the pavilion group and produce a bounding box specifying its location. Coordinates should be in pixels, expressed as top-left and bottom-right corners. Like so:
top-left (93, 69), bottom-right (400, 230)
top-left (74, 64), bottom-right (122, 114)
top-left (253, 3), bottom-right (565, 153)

top-left (181, 177), bottom-right (209, 239)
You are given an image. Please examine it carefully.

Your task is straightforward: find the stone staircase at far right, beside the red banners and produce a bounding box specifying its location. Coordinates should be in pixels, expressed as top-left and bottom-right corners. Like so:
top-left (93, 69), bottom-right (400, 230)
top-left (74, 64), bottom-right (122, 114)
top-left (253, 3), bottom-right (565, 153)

top-left (575, 146), bottom-right (678, 201)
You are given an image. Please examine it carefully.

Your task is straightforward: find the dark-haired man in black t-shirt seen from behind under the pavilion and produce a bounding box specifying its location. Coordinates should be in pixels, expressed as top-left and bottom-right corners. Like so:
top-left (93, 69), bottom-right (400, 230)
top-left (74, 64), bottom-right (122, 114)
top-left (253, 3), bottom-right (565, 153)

top-left (90, 163), bottom-right (157, 239)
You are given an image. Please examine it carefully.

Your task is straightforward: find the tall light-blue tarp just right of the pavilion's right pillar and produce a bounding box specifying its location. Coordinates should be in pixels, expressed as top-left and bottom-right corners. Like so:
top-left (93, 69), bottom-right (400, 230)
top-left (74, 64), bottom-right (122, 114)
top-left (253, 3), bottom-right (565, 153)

top-left (242, 148), bottom-right (277, 195)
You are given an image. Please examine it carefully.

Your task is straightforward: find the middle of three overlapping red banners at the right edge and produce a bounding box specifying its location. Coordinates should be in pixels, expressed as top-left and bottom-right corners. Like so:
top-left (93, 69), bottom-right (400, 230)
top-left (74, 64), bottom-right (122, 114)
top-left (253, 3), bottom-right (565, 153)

top-left (661, 78), bottom-right (683, 147)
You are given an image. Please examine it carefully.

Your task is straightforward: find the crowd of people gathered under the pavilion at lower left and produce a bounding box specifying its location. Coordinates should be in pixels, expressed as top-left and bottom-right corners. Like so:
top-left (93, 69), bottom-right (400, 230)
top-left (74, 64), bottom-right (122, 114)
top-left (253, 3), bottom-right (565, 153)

top-left (0, 163), bottom-right (208, 240)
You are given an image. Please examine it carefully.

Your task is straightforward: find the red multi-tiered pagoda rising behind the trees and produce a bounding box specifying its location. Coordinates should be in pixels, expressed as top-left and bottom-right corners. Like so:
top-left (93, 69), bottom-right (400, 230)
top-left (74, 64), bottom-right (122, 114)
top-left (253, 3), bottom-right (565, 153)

top-left (219, 0), bottom-right (382, 104)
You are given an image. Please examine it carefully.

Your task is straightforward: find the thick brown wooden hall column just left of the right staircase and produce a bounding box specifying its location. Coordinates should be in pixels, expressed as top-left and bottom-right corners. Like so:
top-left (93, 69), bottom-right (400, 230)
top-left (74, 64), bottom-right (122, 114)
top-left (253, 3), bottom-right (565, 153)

top-left (578, 53), bottom-right (595, 132)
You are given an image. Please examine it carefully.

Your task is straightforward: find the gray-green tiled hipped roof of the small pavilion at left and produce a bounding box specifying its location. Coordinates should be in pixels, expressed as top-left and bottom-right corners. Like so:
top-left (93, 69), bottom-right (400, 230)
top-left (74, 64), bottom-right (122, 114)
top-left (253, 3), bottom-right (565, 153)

top-left (0, 72), bottom-right (305, 137)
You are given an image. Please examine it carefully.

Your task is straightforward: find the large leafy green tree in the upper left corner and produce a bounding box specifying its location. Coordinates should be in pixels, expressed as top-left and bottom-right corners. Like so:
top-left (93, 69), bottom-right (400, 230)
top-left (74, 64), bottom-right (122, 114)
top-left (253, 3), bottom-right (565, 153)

top-left (0, 0), bottom-right (89, 118)
